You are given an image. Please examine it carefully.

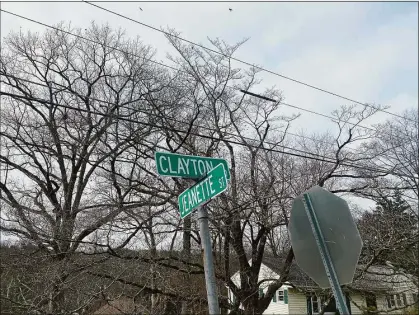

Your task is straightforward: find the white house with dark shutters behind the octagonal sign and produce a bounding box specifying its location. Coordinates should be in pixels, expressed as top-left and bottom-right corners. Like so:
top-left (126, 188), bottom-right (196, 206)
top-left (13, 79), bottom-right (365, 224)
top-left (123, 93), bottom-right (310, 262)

top-left (228, 258), bottom-right (418, 315)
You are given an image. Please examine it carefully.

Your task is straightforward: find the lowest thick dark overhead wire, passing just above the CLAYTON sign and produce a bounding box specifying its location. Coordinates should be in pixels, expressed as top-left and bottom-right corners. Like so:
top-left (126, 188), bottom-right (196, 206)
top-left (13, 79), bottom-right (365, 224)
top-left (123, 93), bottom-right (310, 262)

top-left (0, 91), bottom-right (406, 177)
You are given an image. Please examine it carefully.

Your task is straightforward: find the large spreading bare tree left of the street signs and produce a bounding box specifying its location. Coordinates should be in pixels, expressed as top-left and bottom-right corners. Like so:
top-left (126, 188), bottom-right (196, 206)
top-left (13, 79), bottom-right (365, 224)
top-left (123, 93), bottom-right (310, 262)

top-left (0, 24), bottom-right (171, 313)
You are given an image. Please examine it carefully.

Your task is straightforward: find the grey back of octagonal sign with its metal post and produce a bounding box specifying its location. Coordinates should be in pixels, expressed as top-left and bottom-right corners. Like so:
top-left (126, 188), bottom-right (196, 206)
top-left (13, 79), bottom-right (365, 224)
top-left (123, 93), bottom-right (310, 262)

top-left (288, 186), bottom-right (362, 315)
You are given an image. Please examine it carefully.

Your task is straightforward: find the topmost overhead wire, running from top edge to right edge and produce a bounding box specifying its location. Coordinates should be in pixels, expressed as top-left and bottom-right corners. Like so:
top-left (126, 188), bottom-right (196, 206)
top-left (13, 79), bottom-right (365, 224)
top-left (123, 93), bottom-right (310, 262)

top-left (82, 0), bottom-right (413, 121)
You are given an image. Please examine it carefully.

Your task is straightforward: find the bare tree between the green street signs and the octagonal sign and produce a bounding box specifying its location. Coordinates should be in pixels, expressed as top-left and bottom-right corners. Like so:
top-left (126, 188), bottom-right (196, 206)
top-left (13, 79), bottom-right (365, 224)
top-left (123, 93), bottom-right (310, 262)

top-left (158, 31), bottom-right (390, 314)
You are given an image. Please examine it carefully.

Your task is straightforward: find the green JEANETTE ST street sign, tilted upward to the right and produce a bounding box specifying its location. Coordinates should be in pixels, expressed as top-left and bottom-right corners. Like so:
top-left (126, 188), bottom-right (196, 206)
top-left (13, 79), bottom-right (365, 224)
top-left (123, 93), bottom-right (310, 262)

top-left (178, 164), bottom-right (227, 219)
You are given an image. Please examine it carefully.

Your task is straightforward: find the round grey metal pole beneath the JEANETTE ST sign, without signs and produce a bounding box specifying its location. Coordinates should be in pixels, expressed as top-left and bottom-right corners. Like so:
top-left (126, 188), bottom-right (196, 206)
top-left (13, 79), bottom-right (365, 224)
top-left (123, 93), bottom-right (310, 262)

top-left (198, 205), bottom-right (220, 315)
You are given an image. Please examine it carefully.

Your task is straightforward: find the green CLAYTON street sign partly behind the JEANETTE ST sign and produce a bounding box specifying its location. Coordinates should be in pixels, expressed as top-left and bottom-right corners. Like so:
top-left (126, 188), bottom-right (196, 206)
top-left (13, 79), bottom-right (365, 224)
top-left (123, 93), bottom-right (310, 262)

top-left (154, 152), bottom-right (230, 179)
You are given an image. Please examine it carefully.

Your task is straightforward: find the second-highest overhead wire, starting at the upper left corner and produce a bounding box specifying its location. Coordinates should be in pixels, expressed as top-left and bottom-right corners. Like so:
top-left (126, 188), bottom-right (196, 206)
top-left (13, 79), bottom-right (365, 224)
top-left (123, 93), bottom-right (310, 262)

top-left (0, 9), bottom-right (394, 131)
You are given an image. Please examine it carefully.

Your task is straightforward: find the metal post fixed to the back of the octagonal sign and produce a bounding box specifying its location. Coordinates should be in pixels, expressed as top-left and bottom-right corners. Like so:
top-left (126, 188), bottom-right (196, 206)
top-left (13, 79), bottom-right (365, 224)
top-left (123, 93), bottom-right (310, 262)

top-left (303, 194), bottom-right (350, 315)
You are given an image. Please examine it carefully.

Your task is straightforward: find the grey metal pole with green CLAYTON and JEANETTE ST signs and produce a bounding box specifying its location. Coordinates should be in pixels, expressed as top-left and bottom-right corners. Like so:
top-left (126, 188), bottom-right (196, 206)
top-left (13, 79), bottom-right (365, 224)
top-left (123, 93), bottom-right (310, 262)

top-left (155, 152), bottom-right (230, 315)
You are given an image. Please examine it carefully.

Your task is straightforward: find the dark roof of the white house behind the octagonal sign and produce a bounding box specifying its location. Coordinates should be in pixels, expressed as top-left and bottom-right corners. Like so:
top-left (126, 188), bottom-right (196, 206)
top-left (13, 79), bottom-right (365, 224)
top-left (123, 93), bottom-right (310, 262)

top-left (253, 255), bottom-right (414, 292)
